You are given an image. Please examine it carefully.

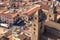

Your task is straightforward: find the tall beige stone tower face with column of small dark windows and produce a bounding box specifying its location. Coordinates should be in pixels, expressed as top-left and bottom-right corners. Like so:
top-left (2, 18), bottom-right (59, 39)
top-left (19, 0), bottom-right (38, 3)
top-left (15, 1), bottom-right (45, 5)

top-left (31, 10), bottom-right (40, 40)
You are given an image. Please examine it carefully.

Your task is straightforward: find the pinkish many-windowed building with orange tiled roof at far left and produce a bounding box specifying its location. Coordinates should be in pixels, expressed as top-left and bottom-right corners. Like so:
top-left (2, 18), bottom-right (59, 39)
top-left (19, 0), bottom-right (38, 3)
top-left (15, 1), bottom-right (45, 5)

top-left (0, 11), bottom-right (20, 24)
